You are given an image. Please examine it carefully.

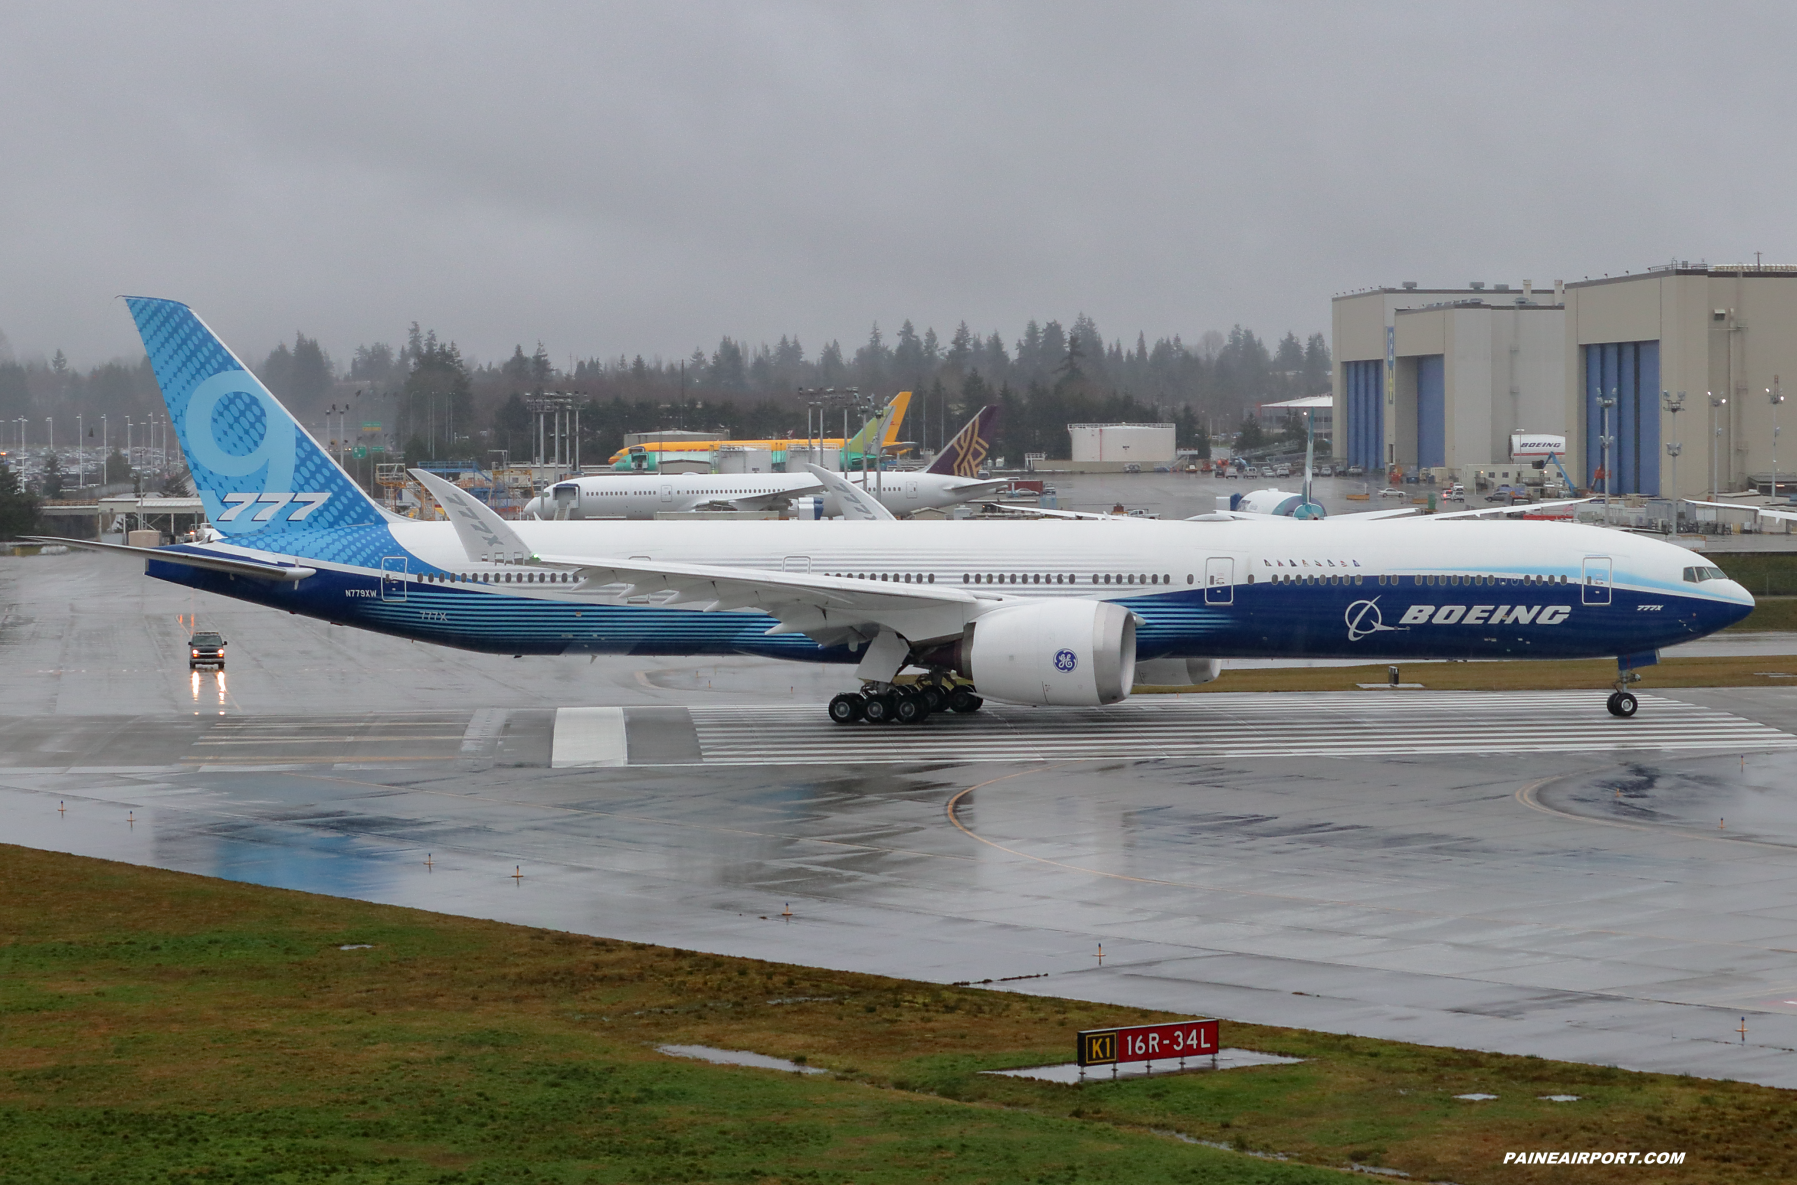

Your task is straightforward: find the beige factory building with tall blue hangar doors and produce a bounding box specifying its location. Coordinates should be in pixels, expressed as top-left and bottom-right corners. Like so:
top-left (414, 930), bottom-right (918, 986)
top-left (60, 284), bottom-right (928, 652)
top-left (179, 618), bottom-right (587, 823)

top-left (1332, 263), bottom-right (1797, 498)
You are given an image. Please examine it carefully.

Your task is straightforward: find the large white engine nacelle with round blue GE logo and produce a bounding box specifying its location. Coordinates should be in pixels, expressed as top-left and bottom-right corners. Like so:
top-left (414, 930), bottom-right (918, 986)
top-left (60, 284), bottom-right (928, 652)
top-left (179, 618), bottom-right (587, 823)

top-left (954, 601), bottom-right (1136, 707)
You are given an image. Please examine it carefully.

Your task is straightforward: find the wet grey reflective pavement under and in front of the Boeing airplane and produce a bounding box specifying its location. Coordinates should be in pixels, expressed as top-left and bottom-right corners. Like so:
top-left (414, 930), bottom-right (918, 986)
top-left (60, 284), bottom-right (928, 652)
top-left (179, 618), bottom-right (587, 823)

top-left (10, 556), bottom-right (1797, 1086)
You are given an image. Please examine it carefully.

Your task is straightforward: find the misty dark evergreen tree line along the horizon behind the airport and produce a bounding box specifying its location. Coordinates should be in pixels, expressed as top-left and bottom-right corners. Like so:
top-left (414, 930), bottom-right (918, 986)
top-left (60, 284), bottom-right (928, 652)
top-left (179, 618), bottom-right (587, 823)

top-left (0, 313), bottom-right (1330, 464)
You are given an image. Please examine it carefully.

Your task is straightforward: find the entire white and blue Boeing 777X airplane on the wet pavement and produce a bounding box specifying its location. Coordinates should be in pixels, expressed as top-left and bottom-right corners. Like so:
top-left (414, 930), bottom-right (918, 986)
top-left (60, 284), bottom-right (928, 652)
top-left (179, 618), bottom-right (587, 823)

top-left (42, 297), bottom-right (1754, 723)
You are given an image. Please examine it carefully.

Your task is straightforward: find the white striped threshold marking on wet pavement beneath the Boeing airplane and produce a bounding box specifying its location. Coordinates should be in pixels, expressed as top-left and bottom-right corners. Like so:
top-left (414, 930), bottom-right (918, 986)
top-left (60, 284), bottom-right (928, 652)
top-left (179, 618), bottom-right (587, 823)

top-left (675, 691), bottom-right (1797, 764)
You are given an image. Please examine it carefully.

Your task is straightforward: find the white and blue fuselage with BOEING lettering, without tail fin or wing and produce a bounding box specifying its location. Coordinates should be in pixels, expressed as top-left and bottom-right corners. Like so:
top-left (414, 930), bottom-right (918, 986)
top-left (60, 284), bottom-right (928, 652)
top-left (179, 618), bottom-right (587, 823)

top-left (149, 520), bottom-right (1754, 662)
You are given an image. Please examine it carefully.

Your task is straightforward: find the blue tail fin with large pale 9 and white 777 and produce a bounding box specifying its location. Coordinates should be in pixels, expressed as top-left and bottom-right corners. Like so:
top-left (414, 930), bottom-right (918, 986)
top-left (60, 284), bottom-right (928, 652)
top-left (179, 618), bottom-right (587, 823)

top-left (126, 297), bottom-right (386, 545)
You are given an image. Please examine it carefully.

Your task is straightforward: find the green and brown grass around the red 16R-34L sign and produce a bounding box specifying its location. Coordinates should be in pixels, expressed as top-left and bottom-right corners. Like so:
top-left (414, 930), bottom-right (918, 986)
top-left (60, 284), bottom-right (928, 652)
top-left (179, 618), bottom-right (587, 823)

top-left (0, 847), bottom-right (1797, 1185)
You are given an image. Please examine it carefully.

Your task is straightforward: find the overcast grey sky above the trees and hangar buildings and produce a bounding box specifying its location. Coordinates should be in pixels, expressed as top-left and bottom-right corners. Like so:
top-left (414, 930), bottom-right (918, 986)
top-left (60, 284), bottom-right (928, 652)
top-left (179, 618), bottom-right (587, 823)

top-left (0, 0), bottom-right (1797, 365)
